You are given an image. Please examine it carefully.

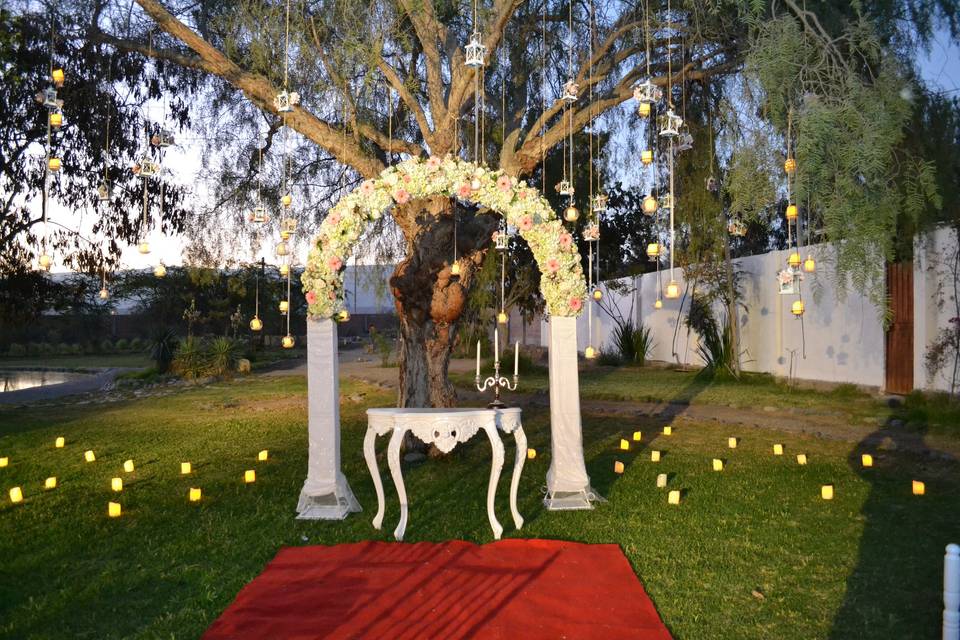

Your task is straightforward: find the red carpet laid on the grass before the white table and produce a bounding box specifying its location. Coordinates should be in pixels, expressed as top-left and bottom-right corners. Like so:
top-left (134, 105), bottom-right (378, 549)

top-left (204, 540), bottom-right (670, 640)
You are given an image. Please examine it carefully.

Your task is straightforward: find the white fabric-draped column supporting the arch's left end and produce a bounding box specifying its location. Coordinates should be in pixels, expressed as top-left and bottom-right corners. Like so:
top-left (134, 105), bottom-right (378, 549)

top-left (297, 318), bottom-right (360, 520)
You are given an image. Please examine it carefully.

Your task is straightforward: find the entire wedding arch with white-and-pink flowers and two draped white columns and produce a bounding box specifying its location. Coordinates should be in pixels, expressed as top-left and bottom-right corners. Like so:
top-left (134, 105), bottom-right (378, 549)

top-left (297, 156), bottom-right (595, 519)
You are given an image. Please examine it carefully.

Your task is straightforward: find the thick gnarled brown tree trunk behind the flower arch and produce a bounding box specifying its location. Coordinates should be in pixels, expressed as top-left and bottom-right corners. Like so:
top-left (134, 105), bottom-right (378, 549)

top-left (390, 197), bottom-right (499, 407)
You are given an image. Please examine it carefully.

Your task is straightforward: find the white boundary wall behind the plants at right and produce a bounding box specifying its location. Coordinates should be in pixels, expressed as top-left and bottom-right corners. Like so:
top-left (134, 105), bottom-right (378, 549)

top-left (541, 228), bottom-right (956, 390)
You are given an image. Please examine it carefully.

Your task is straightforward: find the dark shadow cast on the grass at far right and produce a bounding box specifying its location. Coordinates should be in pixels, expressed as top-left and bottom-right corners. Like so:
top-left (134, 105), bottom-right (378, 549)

top-left (828, 426), bottom-right (960, 640)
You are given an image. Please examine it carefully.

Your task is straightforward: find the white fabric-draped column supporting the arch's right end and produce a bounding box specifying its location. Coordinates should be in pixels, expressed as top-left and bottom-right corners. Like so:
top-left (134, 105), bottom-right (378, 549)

top-left (544, 316), bottom-right (597, 509)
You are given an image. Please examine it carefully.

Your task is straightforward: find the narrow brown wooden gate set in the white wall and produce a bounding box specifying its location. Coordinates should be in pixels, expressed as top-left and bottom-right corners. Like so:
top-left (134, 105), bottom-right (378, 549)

top-left (884, 262), bottom-right (913, 393)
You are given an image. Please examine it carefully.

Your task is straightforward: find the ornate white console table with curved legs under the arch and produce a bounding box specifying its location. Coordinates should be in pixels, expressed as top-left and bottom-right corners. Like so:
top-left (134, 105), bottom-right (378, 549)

top-left (363, 407), bottom-right (527, 540)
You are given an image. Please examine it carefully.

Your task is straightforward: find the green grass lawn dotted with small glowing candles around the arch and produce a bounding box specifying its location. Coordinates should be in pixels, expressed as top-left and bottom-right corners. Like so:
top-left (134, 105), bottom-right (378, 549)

top-left (0, 377), bottom-right (960, 640)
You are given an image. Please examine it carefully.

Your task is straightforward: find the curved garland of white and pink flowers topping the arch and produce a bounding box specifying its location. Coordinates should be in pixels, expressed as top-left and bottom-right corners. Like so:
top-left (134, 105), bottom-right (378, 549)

top-left (301, 156), bottom-right (587, 318)
